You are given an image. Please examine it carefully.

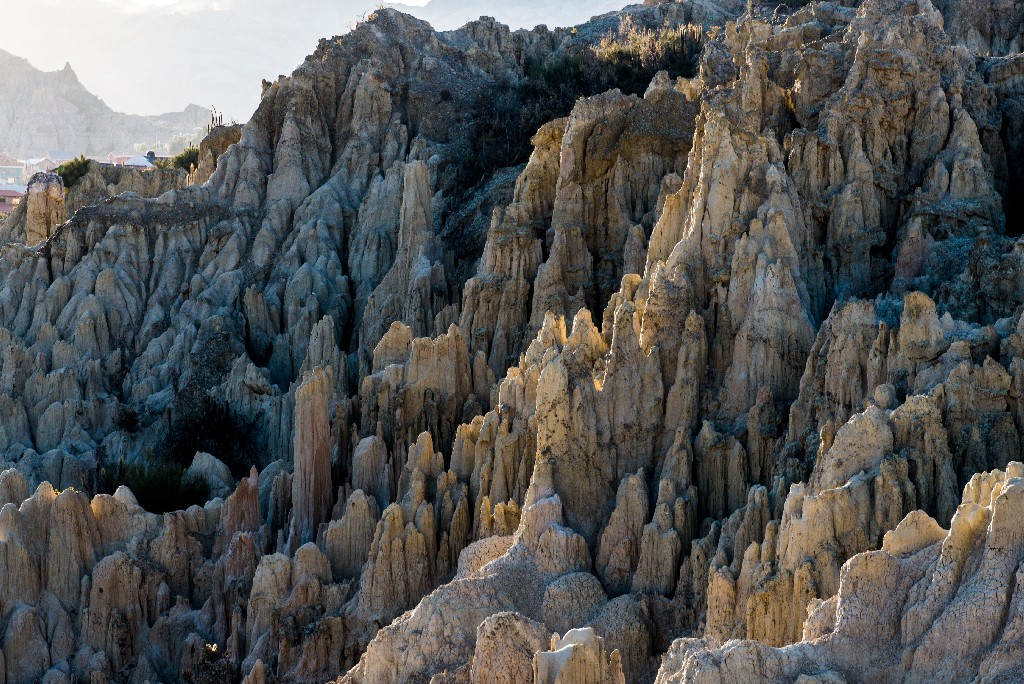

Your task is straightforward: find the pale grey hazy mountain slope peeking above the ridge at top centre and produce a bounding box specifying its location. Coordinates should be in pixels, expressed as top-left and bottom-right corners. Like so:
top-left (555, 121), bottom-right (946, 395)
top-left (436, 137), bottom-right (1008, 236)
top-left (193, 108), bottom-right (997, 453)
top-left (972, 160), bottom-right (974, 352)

top-left (388, 0), bottom-right (631, 31)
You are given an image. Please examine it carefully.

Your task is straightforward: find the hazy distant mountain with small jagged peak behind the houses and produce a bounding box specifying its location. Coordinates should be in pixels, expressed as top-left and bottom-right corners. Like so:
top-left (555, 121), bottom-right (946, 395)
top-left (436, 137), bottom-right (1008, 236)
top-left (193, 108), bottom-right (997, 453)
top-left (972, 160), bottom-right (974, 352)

top-left (0, 50), bottom-right (210, 159)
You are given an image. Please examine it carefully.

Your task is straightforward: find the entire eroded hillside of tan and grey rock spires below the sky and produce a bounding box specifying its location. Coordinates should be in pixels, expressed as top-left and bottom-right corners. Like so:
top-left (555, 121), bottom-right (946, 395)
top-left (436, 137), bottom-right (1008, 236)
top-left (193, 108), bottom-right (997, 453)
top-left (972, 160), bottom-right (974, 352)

top-left (0, 0), bottom-right (1024, 684)
